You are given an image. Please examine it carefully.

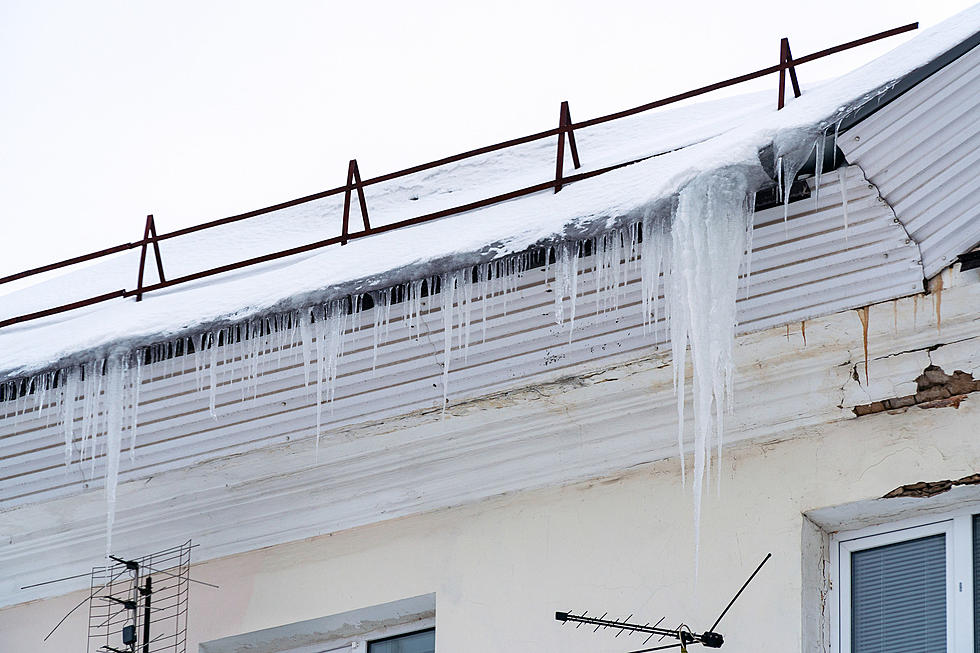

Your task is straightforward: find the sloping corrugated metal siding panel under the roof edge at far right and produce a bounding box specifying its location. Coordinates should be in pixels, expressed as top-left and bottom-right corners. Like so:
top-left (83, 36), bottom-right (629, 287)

top-left (839, 40), bottom-right (980, 277)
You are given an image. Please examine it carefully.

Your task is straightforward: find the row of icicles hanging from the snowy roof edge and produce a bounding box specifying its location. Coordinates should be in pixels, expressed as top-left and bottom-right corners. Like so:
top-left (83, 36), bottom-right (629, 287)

top-left (0, 145), bottom-right (847, 568)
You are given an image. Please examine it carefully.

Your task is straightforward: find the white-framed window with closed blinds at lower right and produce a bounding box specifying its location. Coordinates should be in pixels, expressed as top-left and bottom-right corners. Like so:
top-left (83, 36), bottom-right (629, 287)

top-left (831, 513), bottom-right (980, 653)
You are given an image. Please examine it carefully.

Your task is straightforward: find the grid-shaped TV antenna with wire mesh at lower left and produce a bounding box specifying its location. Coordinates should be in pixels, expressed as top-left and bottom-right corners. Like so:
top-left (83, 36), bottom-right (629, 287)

top-left (28, 540), bottom-right (218, 653)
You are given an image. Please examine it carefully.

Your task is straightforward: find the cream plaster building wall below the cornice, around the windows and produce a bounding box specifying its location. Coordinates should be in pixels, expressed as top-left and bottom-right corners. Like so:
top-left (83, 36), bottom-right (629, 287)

top-left (0, 395), bottom-right (980, 653)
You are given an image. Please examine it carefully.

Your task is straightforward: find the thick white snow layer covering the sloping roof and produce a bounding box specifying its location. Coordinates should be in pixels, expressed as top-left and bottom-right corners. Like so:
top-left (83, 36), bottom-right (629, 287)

top-left (0, 6), bottom-right (980, 379)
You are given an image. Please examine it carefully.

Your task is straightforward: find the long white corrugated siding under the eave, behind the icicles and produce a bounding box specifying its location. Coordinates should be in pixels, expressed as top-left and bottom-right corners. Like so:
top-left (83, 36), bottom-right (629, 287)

top-left (0, 166), bottom-right (922, 507)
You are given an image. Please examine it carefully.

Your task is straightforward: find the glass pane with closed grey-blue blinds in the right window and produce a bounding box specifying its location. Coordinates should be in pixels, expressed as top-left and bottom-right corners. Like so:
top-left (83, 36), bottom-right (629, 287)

top-left (851, 534), bottom-right (946, 653)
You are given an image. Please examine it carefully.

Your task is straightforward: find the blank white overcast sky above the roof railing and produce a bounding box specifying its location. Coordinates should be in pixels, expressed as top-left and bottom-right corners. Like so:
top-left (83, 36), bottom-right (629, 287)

top-left (0, 0), bottom-right (973, 278)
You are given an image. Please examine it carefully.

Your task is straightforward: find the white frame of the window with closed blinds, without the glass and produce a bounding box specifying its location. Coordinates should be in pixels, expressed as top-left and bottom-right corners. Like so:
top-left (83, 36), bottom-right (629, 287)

top-left (828, 506), bottom-right (978, 653)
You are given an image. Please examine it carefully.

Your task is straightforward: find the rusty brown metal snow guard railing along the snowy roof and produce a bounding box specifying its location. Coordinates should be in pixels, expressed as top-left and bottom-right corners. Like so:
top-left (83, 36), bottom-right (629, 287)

top-left (0, 23), bottom-right (919, 327)
